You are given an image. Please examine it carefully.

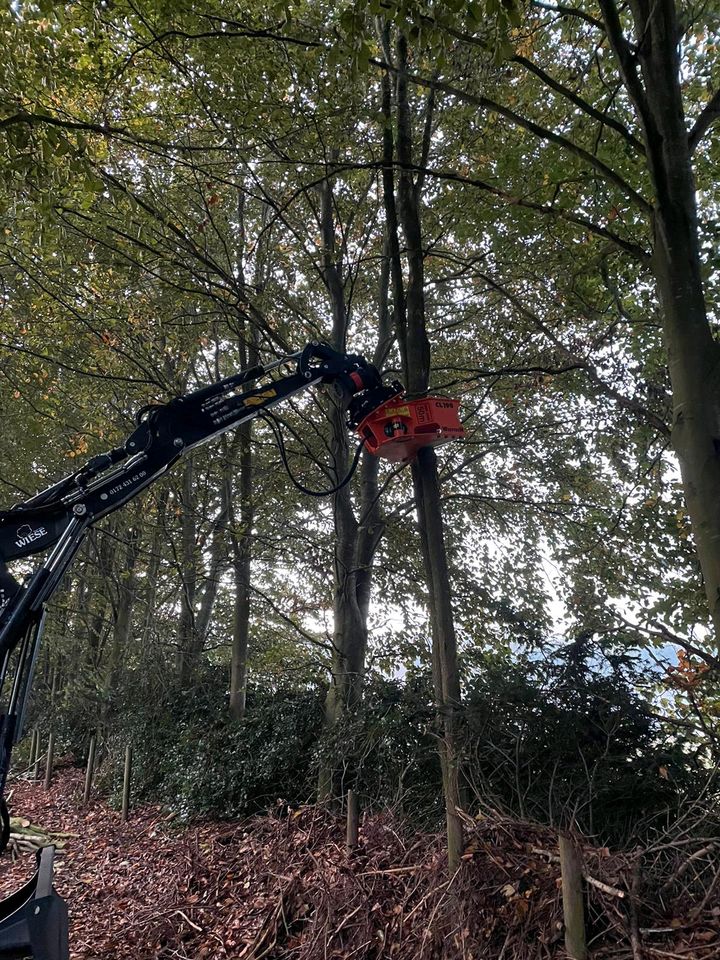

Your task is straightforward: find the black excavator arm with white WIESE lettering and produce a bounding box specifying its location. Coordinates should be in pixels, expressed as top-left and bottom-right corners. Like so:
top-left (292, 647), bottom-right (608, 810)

top-left (0, 342), bottom-right (402, 960)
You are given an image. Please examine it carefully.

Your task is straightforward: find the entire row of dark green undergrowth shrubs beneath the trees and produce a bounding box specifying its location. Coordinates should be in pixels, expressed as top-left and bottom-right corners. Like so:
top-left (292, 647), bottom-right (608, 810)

top-left (43, 660), bottom-right (709, 844)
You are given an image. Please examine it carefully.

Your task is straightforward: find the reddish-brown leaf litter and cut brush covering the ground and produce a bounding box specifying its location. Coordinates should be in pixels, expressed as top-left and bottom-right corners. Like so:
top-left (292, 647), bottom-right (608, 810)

top-left (1, 771), bottom-right (720, 960)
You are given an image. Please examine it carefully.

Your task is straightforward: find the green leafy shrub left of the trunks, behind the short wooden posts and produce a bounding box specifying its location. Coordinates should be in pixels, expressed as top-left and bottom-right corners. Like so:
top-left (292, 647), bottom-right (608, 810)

top-left (102, 671), bottom-right (322, 817)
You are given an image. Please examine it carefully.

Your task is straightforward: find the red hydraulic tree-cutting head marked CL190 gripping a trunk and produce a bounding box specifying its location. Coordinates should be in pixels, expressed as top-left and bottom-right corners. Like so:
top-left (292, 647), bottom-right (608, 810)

top-left (357, 393), bottom-right (465, 463)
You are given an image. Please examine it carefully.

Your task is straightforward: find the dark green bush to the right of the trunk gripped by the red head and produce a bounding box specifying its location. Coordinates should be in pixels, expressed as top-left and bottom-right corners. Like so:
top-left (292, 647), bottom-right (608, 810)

top-left (466, 637), bottom-right (696, 844)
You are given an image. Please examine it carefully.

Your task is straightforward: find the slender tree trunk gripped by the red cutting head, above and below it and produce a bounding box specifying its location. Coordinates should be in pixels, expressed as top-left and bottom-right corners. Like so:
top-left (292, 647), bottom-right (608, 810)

top-left (385, 35), bottom-right (463, 872)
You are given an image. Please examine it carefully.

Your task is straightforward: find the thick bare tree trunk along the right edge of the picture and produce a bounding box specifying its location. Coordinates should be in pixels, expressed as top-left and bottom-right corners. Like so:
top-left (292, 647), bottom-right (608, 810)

top-left (601, 0), bottom-right (720, 645)
